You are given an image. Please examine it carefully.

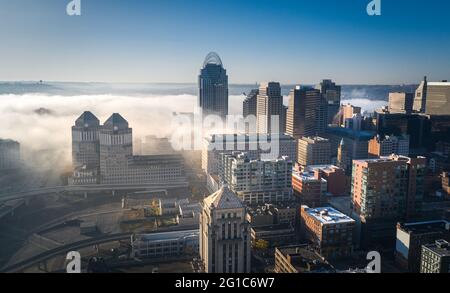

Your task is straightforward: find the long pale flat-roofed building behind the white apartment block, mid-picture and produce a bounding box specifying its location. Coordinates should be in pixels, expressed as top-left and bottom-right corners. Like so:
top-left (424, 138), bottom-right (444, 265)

top-left (202, 134), bottom-right (297, 175)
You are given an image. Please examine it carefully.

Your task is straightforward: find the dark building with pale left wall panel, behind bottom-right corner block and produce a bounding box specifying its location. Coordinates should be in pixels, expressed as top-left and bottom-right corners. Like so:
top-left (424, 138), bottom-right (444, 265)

top-left (395, 220), bottom-right (450, 273)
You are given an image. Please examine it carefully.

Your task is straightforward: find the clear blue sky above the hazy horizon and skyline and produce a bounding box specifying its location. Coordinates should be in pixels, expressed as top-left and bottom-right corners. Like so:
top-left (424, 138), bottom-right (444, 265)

top-left (0, 0), bottom-right (450, 84)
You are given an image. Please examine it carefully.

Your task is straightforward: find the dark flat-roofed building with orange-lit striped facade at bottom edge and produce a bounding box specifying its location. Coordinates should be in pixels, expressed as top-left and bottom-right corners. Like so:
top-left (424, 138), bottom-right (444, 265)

top-left (274, 244), bottom-right (335, 274)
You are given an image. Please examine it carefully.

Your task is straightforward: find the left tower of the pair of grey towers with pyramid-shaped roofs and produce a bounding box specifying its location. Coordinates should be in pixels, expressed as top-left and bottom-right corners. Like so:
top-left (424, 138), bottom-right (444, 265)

top-left (72, 111), bottom-right (100, 169)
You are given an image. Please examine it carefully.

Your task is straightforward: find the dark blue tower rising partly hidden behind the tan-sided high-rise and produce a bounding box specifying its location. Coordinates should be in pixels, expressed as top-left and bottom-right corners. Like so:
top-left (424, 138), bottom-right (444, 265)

top-left (316, 79), bottom-right (341, 124)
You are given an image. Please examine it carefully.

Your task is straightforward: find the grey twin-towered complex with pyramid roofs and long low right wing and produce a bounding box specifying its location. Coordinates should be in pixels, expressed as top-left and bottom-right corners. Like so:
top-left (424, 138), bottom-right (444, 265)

top-left (69, 112), bottom-right (186, 185)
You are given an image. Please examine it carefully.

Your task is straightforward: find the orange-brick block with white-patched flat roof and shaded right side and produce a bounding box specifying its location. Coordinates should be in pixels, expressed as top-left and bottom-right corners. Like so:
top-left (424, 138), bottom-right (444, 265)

top-left (300, 206), bottom-right (355, 259)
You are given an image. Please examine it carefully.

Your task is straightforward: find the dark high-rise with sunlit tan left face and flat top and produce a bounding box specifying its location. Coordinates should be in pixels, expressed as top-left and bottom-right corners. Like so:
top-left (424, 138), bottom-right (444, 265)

top-left (286, 86), bottom-right (326, 139)
